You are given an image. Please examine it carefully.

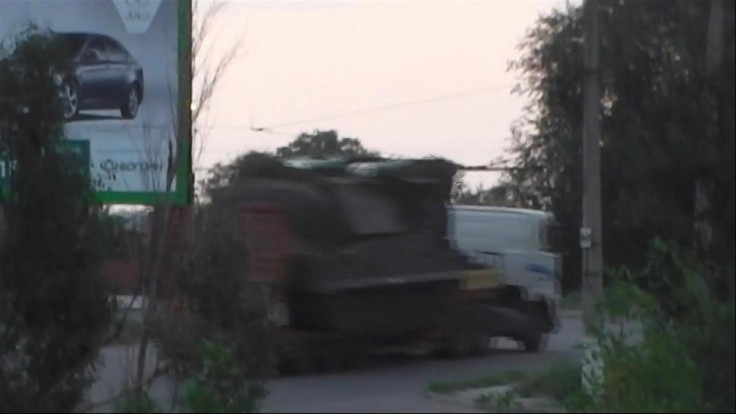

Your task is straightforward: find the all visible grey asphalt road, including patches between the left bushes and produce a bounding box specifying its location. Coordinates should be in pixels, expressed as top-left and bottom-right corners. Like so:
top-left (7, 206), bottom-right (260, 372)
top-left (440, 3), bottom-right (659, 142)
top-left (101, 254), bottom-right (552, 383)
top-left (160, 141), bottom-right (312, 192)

top-left (89, 313), bottom-right (583, 413)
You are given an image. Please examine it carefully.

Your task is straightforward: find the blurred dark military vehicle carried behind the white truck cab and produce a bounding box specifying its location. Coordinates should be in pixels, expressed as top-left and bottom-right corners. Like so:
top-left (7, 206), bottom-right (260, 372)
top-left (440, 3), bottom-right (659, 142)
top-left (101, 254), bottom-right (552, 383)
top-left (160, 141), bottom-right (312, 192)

top-left (214, 157), bottom-right (555, 372)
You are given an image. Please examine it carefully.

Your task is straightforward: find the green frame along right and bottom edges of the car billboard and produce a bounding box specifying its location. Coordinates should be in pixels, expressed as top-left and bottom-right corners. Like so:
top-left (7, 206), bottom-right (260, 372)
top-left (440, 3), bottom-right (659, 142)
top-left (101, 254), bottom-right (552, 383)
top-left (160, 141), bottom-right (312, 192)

top-left (95, 0), bottom-right (194, 205)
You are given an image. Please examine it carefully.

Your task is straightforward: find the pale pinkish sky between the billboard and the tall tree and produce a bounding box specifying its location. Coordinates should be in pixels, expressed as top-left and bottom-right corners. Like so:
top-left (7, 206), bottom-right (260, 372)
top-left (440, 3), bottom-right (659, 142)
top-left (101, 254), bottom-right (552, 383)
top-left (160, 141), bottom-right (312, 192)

top-left (197, 0), bottom-right (561, 188)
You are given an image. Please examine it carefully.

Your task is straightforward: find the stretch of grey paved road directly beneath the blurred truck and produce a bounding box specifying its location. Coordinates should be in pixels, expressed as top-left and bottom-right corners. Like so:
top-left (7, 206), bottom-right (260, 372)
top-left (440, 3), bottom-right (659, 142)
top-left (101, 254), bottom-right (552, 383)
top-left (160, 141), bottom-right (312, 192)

top-left (264, 314), bottom-right (583, 413)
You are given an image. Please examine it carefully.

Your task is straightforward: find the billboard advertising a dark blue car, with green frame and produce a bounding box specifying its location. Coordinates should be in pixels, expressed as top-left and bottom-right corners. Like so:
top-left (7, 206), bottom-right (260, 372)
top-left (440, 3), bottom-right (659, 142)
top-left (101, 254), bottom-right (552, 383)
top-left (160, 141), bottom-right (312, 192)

top-left (0, 0), bottom-right (192, 204)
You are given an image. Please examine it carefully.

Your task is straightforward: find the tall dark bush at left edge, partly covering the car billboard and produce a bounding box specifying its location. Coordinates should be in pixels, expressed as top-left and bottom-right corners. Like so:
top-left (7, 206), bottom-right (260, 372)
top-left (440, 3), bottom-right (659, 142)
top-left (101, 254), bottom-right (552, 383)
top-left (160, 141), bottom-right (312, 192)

top-left (0, 29), bottom-right (112, 412)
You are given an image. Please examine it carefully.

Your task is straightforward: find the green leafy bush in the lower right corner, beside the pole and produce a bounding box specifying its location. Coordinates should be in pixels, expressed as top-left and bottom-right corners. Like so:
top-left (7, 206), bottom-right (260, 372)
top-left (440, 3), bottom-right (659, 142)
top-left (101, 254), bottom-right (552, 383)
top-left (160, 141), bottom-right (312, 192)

top-left (567, 241), bottom-right (736, 412)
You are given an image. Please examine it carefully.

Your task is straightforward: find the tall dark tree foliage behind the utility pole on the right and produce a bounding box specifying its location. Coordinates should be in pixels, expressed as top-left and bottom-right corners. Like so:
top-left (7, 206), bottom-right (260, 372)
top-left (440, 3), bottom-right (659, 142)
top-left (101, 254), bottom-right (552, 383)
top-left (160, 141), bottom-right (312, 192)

top-left (504, 0), bottom-right (736, 291)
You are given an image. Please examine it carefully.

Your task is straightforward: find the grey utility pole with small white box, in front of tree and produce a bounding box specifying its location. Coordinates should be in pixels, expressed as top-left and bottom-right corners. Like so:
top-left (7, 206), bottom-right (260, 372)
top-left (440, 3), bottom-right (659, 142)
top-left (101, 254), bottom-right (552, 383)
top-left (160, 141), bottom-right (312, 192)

top-left (580, 0), bottom-right (603, 330)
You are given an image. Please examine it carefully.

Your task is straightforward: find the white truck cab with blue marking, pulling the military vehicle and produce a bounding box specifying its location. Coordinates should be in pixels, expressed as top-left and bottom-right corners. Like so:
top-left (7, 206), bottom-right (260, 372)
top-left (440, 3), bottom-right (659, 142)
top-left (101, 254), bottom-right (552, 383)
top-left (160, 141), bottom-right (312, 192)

top-left (448, 205), bottom-right (562, 350)
